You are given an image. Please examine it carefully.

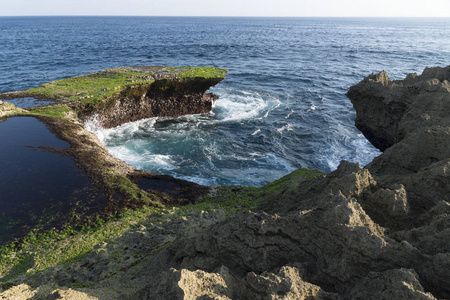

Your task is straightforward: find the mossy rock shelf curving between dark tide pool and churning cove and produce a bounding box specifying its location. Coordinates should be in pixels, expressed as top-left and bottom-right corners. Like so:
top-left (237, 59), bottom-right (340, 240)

top-left (0, 67), bottom-right (226, 245)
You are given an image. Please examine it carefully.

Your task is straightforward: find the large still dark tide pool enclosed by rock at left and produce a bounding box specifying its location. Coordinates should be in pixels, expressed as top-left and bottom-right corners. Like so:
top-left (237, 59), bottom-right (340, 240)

top-left (0, 117), bottom-right (105, 243)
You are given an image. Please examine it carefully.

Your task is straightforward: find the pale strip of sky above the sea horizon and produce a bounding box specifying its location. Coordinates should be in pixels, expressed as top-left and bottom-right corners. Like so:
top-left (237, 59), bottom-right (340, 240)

top-left (0, 0), bottom-right (450, 17)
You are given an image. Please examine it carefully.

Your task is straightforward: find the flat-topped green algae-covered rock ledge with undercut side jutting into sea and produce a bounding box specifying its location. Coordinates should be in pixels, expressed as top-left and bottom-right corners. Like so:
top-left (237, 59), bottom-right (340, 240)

top-left (0, 66), bottom-right (227, 128)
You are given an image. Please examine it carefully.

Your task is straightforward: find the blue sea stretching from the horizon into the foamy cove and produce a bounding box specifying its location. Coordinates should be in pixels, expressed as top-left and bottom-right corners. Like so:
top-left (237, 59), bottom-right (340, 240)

top-left (0, 17), bottom-right (450, 186)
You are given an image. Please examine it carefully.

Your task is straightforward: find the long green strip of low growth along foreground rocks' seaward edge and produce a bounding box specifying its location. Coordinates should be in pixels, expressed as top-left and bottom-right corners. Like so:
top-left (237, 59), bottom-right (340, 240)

top-left (0, 169), bottom-right (323, 287)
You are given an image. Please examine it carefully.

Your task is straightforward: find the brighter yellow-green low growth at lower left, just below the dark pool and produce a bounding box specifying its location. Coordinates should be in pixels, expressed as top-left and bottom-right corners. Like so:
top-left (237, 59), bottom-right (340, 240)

top-left (0, 206), bottom-right (158, 283)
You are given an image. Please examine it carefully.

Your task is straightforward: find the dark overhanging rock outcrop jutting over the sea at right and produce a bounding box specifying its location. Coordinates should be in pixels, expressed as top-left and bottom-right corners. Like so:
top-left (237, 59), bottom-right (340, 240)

top-left (347, 66), bottom-right (450, 151)
